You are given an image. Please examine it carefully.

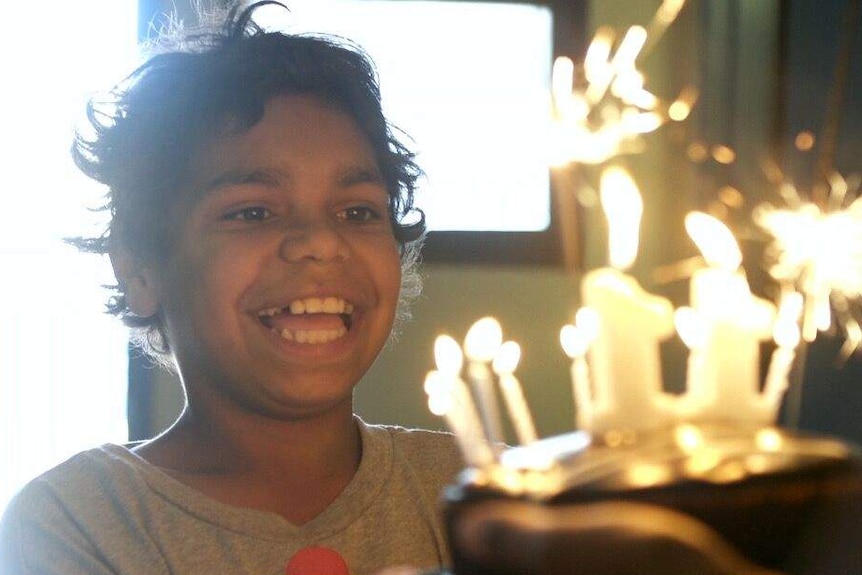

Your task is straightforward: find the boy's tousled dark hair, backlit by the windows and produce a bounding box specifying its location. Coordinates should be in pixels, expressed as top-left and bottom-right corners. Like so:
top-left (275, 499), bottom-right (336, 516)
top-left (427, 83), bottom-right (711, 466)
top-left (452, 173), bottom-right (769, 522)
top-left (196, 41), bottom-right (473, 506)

top-left (69, 0), bottom-right (426, 363)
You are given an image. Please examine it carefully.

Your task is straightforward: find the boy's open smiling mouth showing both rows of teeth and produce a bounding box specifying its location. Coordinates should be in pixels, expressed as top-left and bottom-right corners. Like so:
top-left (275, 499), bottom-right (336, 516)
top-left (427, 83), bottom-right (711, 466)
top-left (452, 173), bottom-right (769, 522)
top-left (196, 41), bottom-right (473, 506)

top-left (257, 297), bottom-right (353, 344)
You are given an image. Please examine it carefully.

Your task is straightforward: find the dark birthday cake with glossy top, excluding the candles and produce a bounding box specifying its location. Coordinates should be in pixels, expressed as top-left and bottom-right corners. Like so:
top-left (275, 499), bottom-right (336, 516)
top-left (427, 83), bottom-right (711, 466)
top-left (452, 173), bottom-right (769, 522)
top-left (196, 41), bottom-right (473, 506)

top-left (446, 424), bottom-right (862, 575)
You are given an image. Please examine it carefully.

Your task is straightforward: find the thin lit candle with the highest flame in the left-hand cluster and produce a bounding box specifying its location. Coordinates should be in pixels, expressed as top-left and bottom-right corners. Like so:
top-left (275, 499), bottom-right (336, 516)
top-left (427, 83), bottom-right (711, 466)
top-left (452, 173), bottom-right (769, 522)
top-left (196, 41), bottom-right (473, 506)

top-left (464, 317), bottom-right (504, 444)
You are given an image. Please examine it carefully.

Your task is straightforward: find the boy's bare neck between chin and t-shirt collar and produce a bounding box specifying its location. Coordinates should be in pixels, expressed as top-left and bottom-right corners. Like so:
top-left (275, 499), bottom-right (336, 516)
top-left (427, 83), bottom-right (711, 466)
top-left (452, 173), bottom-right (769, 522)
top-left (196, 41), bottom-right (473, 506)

top-left (135, 398), bottom-right (362, 525)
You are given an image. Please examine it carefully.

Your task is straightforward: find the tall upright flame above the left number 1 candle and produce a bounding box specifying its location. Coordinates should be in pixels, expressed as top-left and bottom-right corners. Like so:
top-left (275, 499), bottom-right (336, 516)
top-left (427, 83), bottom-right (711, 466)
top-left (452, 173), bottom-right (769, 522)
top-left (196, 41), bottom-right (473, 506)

top-left (600, 166), bottom-right (643, 269)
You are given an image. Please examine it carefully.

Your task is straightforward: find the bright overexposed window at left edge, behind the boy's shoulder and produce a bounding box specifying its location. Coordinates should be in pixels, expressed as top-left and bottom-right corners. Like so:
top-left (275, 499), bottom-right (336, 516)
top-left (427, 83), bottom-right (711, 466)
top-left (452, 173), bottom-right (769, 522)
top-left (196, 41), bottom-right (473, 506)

top-left (0, 0), bottom-right (137, 509)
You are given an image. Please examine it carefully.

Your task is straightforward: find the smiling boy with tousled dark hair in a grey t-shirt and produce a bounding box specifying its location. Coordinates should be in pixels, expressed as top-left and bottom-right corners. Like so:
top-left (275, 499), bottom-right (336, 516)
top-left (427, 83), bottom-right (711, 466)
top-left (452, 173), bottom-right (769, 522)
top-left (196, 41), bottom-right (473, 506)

top-left (0, 2), bottom-right (461, 575)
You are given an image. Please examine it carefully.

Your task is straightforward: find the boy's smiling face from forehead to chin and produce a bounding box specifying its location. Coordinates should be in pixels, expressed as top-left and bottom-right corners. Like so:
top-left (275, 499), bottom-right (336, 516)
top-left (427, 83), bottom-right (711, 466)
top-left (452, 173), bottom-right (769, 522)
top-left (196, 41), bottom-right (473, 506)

top-left (138, 96), bottom-right (401, 418)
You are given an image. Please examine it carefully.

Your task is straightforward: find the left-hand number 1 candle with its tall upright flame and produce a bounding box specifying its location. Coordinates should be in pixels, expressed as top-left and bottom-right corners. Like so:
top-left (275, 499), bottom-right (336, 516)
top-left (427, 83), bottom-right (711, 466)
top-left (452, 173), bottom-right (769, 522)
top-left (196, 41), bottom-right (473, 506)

top-left (581, 167), bottom-right (673, 432)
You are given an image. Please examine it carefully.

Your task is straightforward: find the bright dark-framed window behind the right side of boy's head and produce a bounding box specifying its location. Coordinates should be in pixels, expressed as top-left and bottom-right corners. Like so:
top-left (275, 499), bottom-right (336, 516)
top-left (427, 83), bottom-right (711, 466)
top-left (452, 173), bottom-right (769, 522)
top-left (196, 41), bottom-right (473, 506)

top-left (258, 0), bottom-right (570, 263)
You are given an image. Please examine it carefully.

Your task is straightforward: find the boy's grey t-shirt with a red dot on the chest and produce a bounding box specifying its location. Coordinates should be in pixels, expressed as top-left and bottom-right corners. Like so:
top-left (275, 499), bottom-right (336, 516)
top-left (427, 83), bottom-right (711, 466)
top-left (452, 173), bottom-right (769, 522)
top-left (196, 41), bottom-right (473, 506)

top-left (0, 421), bottom-right (462, 575)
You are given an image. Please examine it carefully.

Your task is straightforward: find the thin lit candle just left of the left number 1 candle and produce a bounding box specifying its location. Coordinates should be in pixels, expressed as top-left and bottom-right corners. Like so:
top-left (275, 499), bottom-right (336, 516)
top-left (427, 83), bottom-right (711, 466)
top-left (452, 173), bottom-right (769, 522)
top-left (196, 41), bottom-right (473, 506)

top-left (560, 307), bottom-right (601, 429)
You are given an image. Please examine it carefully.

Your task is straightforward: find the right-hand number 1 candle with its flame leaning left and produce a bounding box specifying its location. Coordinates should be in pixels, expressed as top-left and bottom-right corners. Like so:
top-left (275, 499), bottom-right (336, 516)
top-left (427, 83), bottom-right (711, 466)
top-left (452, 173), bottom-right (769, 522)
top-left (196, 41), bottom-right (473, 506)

top-left (685, 212), bottom-right (775, 419)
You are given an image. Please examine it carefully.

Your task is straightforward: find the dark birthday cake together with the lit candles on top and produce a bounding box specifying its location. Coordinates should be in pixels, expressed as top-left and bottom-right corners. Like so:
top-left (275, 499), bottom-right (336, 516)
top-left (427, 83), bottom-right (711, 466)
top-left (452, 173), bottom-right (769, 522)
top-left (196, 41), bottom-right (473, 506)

top-left (425, 195), bottom-right (862, 575)
